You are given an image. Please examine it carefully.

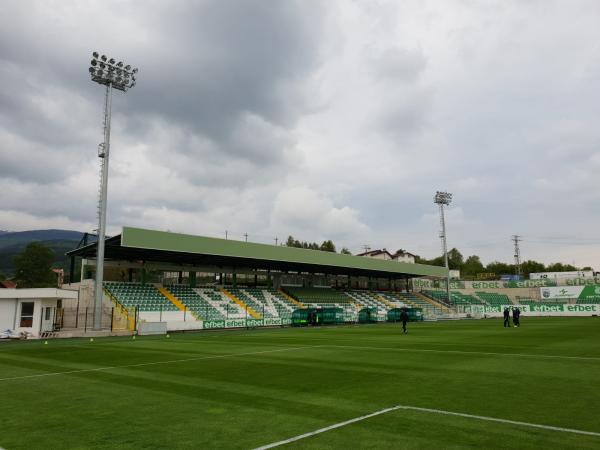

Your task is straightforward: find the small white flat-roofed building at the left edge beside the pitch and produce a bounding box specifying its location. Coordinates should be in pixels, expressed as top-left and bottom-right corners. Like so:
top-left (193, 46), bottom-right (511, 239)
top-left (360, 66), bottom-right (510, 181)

top-left (0, 288), bottom-right (78, 338)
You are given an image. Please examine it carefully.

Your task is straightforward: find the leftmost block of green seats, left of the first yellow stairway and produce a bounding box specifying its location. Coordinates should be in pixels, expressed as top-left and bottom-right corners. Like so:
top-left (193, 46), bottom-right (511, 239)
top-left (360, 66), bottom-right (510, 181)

top-left (104, 281), bottom-right (179, 312)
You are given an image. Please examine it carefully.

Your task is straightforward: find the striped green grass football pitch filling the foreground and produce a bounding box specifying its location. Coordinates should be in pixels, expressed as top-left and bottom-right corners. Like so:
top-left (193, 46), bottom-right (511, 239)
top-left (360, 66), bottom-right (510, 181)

top-left (0, 317), bottom-right (600, 450)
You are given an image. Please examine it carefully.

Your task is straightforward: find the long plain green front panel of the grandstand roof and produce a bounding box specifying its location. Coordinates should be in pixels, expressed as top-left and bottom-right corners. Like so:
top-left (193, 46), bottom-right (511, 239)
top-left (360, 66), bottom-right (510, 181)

top-left (121, 227), bottom-right (448, 278)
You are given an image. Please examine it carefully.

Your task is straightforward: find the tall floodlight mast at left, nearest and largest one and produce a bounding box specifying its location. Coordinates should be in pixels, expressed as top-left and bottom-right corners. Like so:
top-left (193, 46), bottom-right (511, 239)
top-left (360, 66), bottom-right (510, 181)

top-left (88, 52), bottom-right (138, 330)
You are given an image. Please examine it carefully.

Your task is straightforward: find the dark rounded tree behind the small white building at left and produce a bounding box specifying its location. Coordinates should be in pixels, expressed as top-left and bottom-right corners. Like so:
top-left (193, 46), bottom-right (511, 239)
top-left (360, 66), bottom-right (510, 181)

top-left (13, 242), bottom-right (56, 288)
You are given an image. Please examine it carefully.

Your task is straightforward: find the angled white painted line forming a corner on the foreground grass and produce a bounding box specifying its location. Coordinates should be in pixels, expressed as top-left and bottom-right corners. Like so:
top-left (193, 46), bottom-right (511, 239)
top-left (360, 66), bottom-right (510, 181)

top-left (254, 405), bottom-right (600, 450)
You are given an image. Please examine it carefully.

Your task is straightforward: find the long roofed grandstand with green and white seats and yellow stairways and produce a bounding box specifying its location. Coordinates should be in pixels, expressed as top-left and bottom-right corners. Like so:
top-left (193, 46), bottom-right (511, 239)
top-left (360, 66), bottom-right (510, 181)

top-left (63, 227), bottom-right (450, 329)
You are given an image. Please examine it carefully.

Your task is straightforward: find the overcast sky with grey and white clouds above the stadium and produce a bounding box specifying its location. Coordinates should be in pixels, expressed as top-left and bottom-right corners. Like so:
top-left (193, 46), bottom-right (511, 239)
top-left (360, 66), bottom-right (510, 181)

top-left (0, 0), bottom-right (600, 269)
